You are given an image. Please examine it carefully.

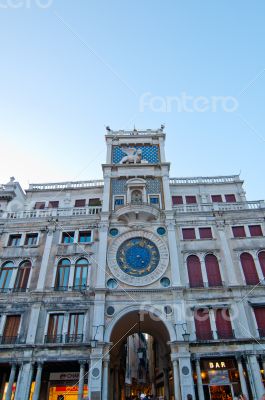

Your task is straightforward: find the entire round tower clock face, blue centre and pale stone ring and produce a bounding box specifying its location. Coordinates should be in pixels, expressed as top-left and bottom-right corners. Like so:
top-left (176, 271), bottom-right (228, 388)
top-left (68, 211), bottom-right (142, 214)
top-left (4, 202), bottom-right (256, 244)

top-left (108, 231), bottom-right (169, 286)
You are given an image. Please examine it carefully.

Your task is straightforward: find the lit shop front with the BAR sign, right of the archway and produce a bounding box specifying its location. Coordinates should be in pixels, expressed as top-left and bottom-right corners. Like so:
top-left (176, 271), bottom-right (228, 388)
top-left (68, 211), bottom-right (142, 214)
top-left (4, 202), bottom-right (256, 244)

top-left (195, 358), bottom-right (241, 400)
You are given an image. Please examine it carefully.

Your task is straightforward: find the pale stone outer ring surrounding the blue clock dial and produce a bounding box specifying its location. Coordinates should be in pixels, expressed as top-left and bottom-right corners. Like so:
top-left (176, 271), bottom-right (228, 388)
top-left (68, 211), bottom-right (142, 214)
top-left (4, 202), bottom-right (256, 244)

top-left (107, 230), bottom-right (169, 286)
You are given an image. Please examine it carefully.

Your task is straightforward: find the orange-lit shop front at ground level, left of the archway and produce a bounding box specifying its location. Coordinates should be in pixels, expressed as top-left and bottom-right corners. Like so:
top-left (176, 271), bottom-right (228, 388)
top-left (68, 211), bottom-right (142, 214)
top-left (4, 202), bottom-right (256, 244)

top-left (48, 372), bottom-right (88, 400)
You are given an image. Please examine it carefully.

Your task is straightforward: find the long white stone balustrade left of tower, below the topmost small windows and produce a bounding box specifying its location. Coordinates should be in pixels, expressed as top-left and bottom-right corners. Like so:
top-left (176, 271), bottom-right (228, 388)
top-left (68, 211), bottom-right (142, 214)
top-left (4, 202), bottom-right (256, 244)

top-left (0, 206), bottom-right (102, 219)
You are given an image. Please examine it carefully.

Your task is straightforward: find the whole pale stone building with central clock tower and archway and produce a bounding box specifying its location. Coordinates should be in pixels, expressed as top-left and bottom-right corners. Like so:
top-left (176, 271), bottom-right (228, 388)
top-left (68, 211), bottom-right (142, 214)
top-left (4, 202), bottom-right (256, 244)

top-left (0, 126), bottom-right (265, 400)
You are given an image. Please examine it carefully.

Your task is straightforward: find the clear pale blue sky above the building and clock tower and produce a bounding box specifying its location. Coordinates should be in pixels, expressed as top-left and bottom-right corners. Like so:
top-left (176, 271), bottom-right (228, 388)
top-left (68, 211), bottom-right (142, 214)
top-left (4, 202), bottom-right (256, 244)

top-left (0, 0), bottom-right (265, 199)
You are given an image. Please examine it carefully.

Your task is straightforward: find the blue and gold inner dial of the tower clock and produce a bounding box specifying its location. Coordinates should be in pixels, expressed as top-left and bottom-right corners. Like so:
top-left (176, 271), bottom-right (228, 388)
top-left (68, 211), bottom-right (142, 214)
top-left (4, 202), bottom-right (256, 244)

top-left (116, 237), bottom-right (160, 277)
